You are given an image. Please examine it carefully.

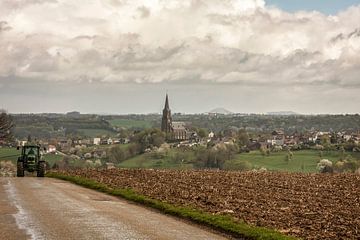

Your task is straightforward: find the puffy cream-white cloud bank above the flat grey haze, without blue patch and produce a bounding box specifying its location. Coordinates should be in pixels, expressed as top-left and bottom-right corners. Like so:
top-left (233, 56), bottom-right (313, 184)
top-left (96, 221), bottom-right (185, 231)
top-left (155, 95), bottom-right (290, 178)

top-left (0, 0), bottom-right (360, 88)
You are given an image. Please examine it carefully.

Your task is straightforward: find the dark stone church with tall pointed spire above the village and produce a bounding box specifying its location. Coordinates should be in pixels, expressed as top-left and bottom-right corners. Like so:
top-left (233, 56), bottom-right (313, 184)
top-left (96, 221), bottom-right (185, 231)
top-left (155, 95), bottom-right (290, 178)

top-left (161, 94), bottom-right (193, 141)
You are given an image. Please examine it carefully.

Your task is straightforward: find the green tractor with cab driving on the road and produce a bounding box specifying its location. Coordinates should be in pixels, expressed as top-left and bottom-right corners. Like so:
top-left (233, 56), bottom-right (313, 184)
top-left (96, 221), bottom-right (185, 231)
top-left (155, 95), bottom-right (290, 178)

top-left (17, 145), bottom-right (46, 177)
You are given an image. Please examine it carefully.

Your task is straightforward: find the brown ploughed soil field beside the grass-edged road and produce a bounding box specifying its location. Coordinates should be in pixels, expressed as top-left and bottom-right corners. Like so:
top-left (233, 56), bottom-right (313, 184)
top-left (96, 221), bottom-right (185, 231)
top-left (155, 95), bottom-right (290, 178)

top-left (56, 169), bottom-right (360, 239)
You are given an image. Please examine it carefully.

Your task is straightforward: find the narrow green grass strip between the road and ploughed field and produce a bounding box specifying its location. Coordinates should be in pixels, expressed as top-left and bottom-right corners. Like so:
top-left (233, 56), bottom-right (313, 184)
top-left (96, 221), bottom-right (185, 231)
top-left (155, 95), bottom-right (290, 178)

top-left (46, 172), bottom-right (296, 240)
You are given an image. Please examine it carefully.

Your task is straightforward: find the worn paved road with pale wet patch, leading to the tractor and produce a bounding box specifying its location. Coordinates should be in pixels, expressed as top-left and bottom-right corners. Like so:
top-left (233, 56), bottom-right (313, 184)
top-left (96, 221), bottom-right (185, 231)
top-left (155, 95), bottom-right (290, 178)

top-left (0, 177), bottom-right (226, 240)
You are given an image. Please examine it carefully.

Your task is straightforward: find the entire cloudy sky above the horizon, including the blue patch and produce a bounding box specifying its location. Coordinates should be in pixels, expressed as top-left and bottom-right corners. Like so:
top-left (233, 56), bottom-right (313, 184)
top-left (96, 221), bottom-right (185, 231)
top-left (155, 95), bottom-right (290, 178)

top-left (0, 0), bottom-right (360, 114)
